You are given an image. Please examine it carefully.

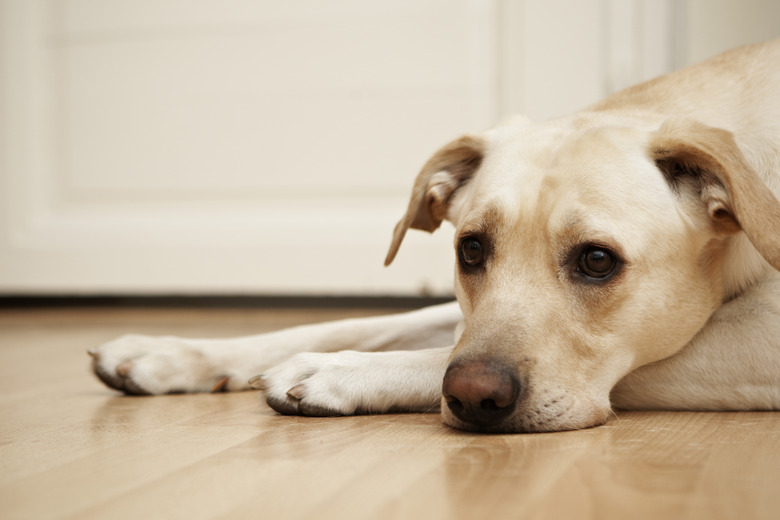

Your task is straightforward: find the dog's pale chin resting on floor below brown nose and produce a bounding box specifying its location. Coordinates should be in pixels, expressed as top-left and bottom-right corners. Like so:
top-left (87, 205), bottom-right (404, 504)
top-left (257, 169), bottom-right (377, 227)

top-left (442, 403), bottom-right (611, 433)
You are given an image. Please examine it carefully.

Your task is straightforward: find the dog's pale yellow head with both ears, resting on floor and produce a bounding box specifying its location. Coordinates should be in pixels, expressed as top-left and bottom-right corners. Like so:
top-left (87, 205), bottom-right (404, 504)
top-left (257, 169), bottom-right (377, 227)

top-left (387, 115), bottom-right (780, 432)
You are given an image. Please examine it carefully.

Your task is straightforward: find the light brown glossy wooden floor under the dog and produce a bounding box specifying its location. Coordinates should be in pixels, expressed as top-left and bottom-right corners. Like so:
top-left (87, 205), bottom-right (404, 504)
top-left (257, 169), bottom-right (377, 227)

top-left (0, 310), bottom-right (780, 520)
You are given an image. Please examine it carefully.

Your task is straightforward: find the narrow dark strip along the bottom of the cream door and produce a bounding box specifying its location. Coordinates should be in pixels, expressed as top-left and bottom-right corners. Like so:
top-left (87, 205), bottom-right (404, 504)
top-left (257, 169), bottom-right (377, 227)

top-left (0, 295), bottom-right (455, 309)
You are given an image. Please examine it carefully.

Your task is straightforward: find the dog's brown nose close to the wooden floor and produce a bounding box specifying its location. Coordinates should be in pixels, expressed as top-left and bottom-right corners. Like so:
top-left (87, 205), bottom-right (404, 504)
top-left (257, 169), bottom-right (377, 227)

top-left (442, 361), bottom-right (520, 427)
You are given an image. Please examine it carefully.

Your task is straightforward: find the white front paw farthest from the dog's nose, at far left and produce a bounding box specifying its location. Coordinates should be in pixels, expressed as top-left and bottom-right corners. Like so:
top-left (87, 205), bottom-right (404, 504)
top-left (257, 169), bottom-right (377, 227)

top-left (89, 335), bottom-right (241, 395)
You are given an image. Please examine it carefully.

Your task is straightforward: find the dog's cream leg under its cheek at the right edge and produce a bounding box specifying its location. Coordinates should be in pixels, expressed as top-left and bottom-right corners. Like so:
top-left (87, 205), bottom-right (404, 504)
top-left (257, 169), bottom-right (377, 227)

top-left (611, 273), bottom-right (780, 410)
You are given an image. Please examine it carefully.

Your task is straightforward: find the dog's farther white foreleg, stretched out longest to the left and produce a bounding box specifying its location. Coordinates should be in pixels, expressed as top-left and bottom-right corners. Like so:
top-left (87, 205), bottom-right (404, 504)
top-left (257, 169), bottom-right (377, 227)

top-left (90, 302), bottom-right (462, 394)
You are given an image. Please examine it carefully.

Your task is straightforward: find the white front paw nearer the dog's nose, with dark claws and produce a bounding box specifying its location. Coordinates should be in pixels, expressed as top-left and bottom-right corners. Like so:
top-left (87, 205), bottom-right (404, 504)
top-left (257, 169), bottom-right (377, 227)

top-left (249, 351), bottom-right (368, 417)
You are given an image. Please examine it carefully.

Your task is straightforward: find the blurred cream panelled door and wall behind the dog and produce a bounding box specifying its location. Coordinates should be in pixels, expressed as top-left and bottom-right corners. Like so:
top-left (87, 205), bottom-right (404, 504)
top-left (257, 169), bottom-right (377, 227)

top-left (0, 0), bottom-right (780, 296)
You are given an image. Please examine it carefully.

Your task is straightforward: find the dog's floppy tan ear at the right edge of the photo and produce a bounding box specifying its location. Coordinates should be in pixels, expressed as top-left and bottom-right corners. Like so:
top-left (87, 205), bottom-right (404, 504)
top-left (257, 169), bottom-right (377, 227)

top-left (650, 119), bottom-right (780, 270)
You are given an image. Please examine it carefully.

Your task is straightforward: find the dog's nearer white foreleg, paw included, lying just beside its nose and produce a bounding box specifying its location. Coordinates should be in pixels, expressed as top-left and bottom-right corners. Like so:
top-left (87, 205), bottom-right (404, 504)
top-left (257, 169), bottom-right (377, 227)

top-left (252, 347), bottom-right (453, 416)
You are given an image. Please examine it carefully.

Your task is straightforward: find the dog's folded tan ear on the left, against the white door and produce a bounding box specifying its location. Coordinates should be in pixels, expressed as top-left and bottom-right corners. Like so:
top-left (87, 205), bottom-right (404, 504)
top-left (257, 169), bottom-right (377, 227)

top-left (385, 135), bottom-right (486, 265)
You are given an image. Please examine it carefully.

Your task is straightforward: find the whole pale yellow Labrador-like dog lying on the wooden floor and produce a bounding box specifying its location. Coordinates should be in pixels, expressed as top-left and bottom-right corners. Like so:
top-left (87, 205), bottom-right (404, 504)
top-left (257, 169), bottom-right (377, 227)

top-left (90, 40), bottom-right (780, 433)
